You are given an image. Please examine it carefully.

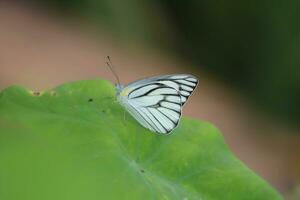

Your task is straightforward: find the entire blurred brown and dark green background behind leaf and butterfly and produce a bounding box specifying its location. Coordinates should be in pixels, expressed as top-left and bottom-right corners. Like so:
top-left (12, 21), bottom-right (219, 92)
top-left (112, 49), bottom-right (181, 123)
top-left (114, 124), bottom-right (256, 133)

top-left (0, 0), bottom-right (300, 200)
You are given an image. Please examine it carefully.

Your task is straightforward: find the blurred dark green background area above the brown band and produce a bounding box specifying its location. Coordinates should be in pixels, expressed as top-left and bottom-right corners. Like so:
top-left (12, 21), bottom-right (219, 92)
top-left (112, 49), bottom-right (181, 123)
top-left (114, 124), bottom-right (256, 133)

top-left (36, 0), bottom-right (300, 123)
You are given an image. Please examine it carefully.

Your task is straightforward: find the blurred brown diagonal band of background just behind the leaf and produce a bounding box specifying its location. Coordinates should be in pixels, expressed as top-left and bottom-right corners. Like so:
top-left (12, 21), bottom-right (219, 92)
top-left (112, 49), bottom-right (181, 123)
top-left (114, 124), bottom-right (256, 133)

top-left (0, 3), bottom-right (300, 198)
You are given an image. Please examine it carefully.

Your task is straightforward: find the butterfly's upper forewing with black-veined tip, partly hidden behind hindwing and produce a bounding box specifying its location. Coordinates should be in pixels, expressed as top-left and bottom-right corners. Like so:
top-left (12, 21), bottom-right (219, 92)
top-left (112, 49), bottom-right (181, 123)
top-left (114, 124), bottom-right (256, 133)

top-left (126, 74), bottom-right (199, 105)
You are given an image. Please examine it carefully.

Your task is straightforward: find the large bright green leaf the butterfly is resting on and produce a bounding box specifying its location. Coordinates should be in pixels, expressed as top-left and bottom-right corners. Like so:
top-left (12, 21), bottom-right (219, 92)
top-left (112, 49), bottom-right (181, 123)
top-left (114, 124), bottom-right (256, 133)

top-left (0, 80), bottom-right (282, 200)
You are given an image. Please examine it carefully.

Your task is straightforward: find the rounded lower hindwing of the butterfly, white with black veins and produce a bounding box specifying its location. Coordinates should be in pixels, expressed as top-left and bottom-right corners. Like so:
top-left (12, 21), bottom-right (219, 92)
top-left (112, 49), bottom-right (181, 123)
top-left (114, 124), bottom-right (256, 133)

top-left (126, 83), bottom-right (182, 134)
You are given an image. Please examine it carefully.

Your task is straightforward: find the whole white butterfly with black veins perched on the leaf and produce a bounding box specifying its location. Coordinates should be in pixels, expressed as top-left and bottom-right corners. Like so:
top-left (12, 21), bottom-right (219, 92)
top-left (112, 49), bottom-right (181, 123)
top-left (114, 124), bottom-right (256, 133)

top-left (107, 57), bottom-right (198, 134)
